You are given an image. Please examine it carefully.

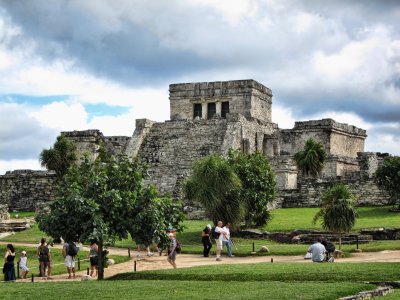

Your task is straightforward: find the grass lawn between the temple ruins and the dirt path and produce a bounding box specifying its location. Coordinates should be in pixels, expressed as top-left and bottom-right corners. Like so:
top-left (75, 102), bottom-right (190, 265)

top-left (2, 206), bottom-right (400, 256)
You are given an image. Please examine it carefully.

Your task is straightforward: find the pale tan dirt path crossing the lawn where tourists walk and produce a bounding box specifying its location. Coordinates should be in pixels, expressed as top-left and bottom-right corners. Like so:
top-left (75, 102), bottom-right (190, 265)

top-left (0, 242), bottom-right (400, 282)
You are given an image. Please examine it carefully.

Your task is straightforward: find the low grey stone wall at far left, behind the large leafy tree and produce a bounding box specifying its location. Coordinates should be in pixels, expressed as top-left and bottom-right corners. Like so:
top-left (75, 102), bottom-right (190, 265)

top-left (0, 170), bottom-right (56, 211)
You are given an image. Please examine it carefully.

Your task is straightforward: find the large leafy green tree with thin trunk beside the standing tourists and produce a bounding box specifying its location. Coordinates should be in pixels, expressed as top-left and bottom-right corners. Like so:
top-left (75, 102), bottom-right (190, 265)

top-left (36, 155), bottom-right (180, 279)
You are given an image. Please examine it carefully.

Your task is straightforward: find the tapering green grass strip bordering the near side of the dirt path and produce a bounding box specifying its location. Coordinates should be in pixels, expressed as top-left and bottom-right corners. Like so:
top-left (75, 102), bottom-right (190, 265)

top-left (113, 257), bottom-right (400, 283)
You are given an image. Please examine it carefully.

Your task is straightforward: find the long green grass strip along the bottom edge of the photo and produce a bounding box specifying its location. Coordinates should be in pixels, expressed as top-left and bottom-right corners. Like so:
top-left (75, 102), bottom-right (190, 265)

top-left (0, 280), bottom-right (375, 300)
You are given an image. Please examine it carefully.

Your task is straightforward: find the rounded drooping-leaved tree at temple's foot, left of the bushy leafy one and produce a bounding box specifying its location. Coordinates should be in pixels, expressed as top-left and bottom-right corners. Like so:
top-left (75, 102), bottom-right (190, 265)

top-left (184, 155), bottom-right (244, 224)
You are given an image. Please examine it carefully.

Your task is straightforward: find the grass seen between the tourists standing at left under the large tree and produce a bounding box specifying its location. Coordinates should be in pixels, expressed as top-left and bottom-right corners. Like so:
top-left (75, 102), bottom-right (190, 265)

top-left (0, 245), bottom-right (129, 276)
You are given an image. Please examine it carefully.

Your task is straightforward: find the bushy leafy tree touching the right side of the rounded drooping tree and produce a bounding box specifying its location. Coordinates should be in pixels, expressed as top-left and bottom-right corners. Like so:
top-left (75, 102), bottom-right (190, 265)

top-left (228, 151), bottom-right (276, 226)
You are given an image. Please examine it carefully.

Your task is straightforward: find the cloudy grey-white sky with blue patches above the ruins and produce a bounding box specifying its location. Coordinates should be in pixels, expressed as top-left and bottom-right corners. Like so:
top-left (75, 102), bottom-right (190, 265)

top-left (0, 0), bottom-right (400, 174)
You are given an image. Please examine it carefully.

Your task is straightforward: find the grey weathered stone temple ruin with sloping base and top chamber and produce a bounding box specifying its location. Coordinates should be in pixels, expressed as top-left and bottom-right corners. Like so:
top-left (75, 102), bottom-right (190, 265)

top-left (0, 80), bottom-right (389, 215)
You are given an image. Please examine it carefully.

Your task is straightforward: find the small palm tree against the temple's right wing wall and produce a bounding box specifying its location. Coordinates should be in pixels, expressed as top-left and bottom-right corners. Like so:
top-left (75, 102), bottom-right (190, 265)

top-left (294, 138), bottom-right (326, 177)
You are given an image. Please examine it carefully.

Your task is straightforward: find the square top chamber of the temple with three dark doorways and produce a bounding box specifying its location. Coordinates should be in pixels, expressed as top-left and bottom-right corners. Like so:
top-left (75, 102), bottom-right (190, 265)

top-left (169, 80), bottom-right (272, 122)
